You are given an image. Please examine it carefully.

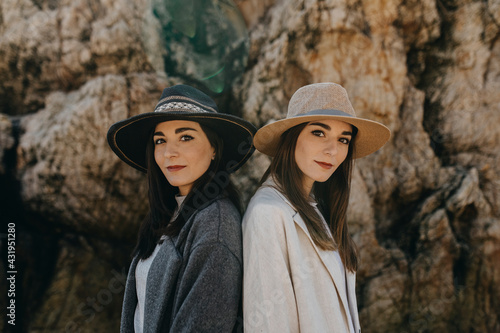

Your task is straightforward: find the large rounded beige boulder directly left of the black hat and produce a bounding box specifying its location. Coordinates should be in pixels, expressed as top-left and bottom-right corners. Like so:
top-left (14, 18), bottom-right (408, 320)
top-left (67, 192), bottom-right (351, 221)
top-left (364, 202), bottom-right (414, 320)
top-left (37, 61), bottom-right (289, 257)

top-left (18, 74), bottom-right (176, 239)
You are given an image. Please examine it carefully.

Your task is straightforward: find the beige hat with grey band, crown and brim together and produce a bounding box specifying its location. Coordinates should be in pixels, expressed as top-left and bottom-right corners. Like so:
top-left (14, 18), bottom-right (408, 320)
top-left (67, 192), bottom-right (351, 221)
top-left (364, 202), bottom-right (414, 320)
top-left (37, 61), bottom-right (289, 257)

top-left (254, 82), bottom-right (391, 158)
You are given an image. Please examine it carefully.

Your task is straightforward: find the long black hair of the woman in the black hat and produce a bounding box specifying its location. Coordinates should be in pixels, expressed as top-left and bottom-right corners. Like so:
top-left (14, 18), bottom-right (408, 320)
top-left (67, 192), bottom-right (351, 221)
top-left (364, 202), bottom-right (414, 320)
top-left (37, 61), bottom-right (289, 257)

top-left (133, 123), bottom-right (241, 259)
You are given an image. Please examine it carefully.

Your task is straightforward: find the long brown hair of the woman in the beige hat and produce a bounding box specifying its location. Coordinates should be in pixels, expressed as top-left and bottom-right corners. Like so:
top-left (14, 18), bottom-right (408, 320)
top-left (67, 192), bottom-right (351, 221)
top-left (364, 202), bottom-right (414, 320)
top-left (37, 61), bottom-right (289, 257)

top-left (260, 123), bottom-right (358, 272)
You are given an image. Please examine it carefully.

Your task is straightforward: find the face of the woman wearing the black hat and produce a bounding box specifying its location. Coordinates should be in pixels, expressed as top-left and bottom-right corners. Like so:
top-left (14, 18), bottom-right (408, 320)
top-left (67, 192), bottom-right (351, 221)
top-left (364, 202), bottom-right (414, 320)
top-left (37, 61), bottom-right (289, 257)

top-left (153, 120), bottom-right (215, 195)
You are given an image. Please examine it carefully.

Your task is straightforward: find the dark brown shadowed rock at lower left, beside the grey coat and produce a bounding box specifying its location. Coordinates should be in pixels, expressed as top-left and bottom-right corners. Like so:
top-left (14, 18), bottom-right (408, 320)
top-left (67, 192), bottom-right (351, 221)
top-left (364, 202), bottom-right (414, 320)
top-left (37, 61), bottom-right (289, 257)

top-left (27, 237), bottom-right (128, 332)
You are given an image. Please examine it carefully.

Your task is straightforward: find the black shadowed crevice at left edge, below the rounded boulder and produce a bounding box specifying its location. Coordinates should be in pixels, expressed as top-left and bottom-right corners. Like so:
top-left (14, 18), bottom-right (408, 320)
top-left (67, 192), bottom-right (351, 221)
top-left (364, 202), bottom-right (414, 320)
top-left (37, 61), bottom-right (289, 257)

top-left (0, 118), bottom-right (59, 332)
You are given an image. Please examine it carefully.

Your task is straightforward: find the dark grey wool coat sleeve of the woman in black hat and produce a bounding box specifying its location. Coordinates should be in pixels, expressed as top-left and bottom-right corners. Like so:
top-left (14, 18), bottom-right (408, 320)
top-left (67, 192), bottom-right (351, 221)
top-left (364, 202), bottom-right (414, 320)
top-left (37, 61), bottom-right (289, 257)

top-left (170, 237), bottom-right (243, 332)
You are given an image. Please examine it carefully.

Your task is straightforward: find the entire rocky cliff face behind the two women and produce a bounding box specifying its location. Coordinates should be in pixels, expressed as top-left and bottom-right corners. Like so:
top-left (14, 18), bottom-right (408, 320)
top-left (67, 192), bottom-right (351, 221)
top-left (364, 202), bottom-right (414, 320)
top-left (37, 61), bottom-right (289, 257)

top-left (0, 0), bottom-right (500, 332)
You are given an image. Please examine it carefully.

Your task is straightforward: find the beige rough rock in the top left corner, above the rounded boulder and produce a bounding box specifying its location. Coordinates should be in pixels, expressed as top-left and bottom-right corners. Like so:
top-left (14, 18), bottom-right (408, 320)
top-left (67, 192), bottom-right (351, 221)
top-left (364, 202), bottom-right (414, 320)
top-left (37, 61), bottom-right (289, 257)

top-left (0, 0), bottom-right (151, 114)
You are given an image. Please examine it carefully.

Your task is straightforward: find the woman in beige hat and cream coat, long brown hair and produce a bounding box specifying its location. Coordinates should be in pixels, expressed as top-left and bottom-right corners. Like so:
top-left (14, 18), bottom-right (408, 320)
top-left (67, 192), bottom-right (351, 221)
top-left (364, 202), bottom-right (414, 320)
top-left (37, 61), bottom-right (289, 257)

top-left (243, 83), bottom-right (390, 333)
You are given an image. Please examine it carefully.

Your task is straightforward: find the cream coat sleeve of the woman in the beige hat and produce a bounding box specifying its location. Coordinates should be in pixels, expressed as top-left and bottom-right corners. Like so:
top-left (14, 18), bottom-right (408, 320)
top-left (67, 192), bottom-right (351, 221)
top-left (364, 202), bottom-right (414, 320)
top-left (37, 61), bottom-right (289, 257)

top-left (243, 200), bottom-right (299, 332)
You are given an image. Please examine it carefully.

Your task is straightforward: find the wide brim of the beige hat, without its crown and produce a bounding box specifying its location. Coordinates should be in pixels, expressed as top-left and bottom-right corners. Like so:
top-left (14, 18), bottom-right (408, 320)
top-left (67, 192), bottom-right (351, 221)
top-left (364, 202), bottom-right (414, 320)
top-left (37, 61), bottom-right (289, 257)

top-left (254, 110), bottom-right (391, 158)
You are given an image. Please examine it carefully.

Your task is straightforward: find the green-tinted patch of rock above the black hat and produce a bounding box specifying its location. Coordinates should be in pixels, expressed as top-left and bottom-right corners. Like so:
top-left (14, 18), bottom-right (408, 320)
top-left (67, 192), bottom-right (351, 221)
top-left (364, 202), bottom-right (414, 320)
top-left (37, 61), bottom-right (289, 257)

top-left (148, 0), bottom-right (249, 93)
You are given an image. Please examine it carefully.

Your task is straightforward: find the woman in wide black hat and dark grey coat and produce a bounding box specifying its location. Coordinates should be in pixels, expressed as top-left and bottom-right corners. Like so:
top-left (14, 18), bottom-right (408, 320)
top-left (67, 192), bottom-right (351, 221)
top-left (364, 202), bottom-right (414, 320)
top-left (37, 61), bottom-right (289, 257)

top-left (108, 85), bottom-right (256, 332)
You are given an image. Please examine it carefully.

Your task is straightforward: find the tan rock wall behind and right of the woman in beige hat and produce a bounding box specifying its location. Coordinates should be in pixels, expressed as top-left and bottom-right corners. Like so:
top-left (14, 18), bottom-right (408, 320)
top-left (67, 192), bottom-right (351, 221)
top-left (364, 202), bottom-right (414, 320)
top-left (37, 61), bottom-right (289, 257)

top-left (234, 0), bottom-right (500, 332)
